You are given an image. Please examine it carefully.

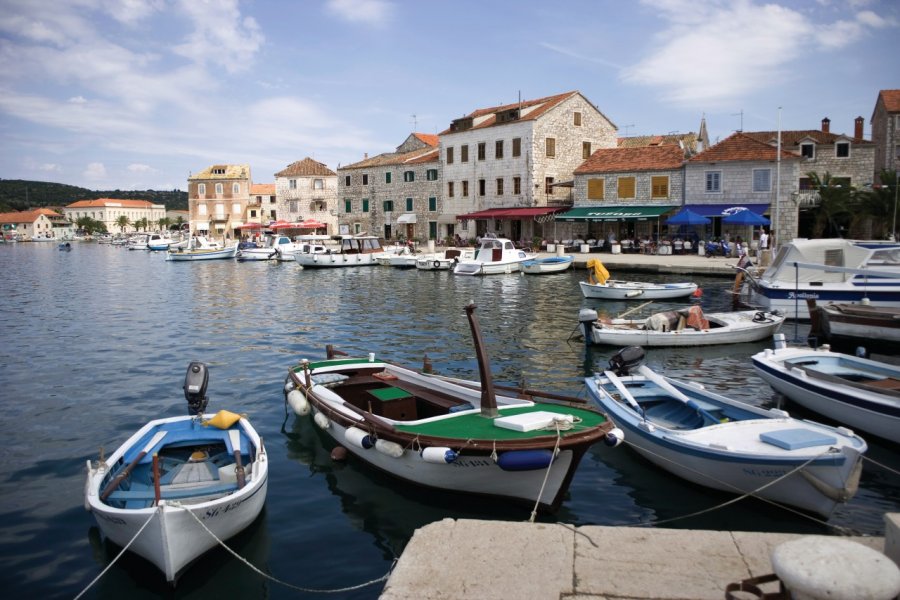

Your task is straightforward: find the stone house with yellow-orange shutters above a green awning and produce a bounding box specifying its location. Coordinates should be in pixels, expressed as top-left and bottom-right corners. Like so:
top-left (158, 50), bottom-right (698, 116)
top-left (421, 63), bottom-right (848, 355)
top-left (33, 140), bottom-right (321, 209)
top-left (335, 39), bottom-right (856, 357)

top-left (568, 143), bottom-right (685, 240)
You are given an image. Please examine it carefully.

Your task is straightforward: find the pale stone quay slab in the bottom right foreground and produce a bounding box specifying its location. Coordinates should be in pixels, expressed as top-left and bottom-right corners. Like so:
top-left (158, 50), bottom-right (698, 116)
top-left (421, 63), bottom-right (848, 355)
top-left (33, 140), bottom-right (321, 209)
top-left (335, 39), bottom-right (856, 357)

top-left (381, 514), bottom-right (900, 600)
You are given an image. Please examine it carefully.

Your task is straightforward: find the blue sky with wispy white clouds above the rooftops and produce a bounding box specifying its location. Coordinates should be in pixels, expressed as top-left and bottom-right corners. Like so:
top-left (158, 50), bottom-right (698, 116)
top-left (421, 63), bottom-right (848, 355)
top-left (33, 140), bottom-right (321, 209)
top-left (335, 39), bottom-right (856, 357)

top-left (0, 0), bottom-right (900, 190)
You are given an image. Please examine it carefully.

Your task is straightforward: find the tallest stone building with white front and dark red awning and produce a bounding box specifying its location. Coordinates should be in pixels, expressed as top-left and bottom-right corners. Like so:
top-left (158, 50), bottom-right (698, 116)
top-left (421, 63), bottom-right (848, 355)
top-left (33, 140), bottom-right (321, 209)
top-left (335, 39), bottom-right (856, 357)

top-left (440, 91), bottom-right (616, 244)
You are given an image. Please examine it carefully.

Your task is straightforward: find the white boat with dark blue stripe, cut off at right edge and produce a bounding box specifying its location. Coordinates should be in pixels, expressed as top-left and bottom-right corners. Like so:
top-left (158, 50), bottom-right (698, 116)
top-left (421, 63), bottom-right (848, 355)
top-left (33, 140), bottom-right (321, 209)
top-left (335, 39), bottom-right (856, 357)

top-left (752, 334), bottom-right (900, 443)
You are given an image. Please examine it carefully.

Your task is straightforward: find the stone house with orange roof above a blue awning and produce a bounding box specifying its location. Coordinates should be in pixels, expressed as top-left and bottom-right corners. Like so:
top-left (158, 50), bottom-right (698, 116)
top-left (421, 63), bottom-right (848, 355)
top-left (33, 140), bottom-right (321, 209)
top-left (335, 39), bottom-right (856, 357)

top-left (684, 132), bottom-right (802, 243)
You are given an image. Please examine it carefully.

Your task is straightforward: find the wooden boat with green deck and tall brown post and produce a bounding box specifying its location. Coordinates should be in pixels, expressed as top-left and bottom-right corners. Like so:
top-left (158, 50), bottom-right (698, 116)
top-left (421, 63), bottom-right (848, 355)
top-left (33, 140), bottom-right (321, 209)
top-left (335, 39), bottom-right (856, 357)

top-left (285, 304), bottom-right (620, 511)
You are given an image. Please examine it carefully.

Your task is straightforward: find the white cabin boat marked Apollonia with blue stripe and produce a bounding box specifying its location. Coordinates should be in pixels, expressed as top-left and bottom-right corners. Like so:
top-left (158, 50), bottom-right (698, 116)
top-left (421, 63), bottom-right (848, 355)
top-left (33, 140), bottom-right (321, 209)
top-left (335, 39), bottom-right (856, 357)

top-left (743, 238), bottom-right (900, 319)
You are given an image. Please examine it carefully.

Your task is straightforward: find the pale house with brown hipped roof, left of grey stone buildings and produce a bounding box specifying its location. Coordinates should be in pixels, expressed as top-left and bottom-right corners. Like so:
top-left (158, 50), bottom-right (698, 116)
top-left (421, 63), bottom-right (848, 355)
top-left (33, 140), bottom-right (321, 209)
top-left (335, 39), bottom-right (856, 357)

top-left (272, 157), bottom-right (340, 234)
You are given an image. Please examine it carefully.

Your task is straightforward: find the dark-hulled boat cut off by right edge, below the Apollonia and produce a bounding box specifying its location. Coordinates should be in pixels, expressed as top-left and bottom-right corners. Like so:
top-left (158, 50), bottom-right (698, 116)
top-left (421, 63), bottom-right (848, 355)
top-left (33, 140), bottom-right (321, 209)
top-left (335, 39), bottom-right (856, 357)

top-left (806, 298), bottom-right (900, 344)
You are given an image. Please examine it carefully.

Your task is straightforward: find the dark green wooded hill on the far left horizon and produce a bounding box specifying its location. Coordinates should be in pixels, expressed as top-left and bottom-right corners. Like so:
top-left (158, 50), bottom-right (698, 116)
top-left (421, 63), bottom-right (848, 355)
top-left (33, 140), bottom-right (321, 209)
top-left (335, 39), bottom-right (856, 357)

top-left (0, 179), bottom-right (188, 212)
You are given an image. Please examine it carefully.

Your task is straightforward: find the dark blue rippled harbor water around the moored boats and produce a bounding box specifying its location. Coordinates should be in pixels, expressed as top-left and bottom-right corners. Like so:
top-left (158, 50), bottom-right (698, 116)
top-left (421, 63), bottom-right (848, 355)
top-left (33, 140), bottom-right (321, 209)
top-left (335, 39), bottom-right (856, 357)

top-left (0, 243), bottom-right (900, 599)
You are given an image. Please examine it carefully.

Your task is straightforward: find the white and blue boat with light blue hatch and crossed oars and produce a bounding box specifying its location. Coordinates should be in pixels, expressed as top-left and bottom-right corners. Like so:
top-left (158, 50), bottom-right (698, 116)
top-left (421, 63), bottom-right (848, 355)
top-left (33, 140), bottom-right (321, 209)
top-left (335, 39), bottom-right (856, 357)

top-left (585, 346), bottom-right (867, 517)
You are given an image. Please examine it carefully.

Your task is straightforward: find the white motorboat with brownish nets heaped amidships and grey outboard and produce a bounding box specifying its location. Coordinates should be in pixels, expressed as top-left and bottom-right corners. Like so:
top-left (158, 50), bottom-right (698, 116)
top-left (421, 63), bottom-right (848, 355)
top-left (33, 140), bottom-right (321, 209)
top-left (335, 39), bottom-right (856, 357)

top-left (578, 306), bottom-right (784, 347)
